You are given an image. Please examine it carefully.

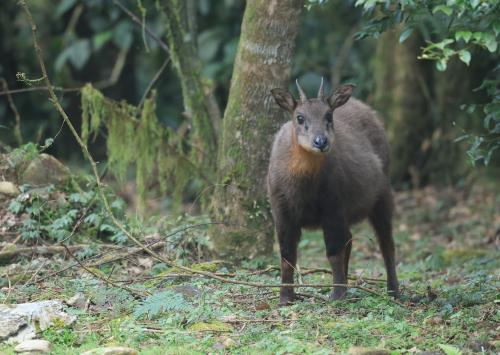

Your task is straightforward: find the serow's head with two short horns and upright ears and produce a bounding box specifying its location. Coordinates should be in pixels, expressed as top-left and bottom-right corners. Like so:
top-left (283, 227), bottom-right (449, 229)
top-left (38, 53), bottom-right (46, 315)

top-left (271, 79), bottom-right (355, 154)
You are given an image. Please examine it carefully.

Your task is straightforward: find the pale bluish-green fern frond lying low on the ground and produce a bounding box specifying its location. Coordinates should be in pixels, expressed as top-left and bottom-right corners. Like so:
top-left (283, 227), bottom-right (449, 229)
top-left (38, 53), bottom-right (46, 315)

top-left (134, 290), bottom-right (192, 319)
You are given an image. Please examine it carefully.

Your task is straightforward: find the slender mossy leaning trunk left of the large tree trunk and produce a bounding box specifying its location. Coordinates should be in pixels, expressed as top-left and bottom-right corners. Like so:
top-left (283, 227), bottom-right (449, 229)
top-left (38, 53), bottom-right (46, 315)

top-left (164, 0), bottom-right (220, 172)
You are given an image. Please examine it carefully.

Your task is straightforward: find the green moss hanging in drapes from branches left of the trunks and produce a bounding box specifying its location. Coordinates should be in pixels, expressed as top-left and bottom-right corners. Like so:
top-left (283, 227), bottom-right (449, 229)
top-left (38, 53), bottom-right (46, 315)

top-left (81, 84), bottom-right (198, 210)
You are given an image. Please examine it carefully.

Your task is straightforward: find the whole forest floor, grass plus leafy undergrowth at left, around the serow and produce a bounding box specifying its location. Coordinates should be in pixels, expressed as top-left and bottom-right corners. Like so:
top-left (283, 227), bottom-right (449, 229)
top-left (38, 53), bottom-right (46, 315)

top-left (0, 177), bottom-right (500, 354)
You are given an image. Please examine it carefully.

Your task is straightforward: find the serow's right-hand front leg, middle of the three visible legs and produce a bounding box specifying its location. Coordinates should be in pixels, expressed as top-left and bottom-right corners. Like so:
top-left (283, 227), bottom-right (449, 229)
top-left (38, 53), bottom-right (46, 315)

top-left (323, 225), bottom-right (350, 300)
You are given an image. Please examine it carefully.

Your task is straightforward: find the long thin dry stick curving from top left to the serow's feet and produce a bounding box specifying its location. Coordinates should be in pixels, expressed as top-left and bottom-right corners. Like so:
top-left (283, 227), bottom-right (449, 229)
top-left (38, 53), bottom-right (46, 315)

top-left (19, 0), bottom-right (404, 306)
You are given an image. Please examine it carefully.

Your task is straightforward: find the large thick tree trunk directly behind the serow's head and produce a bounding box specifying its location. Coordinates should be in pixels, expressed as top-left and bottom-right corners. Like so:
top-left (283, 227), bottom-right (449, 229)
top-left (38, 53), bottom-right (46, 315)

top-left (211, 0), bottom-right (303, 257)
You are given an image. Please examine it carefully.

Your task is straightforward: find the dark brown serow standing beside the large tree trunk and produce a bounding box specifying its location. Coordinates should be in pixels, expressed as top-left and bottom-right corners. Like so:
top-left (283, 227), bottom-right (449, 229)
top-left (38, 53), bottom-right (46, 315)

top-left (267, 81), bottom-right (398, 304)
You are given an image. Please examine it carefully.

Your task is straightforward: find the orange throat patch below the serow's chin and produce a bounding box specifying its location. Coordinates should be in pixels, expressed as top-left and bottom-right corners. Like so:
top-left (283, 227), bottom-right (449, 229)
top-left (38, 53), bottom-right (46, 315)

top-left (288, 129), bottom-right (325, 176)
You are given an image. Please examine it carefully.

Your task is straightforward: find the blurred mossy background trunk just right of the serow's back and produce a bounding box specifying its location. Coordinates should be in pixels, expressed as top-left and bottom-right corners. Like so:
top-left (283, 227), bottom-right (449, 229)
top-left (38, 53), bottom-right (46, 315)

top-left (374, 30), bottom-right (434, 189)
